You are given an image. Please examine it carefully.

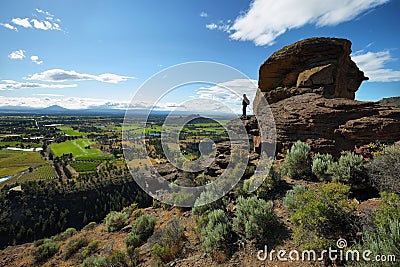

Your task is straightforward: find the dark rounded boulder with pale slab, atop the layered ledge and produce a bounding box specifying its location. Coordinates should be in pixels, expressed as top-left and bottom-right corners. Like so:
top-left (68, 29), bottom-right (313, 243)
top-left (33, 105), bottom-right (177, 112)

top-left (258, 38), bottom-right (368, 107)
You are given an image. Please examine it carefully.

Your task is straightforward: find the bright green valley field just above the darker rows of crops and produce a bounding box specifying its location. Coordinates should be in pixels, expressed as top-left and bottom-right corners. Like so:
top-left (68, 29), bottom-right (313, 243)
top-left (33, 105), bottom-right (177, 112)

top-left (50, 138), bottom-right (104, 159)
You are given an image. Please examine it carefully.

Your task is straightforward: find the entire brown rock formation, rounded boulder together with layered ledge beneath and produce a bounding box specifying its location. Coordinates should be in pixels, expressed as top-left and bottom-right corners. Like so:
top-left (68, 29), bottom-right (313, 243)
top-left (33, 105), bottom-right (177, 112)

top-left (250, 38), bottom-right (400, 155)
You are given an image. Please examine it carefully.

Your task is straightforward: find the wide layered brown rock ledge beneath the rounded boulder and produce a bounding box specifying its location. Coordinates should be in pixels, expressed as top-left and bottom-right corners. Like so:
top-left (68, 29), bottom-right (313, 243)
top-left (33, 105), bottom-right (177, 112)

top-left (253, 93), bottom-right (400, 155)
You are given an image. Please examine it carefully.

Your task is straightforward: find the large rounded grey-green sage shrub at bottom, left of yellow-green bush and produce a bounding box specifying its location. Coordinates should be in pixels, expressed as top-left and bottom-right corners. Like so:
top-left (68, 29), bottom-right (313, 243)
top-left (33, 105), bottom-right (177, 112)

top-left (233, 196), bottom-right (276, 240)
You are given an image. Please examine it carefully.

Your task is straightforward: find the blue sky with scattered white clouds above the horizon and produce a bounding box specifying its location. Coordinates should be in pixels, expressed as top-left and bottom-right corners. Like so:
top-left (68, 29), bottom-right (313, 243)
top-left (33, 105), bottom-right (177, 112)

top-left (0, 0), bottom-right (400, 113)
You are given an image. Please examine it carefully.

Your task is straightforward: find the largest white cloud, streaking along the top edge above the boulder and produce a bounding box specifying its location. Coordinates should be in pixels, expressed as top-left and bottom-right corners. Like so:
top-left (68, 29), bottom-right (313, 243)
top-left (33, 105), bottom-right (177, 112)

top-left (214, 0), bottom-right (390, 45)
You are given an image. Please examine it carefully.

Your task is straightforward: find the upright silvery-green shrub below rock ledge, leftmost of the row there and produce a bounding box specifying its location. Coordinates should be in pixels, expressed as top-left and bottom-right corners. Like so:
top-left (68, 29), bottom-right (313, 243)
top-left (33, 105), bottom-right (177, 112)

top-left (281, 141), bottom-right (310, 178)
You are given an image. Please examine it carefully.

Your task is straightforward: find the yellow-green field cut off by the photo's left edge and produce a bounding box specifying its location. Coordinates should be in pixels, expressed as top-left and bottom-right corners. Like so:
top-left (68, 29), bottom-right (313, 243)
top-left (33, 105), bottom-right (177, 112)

top-left (0, 149), bottom-right (46, 177)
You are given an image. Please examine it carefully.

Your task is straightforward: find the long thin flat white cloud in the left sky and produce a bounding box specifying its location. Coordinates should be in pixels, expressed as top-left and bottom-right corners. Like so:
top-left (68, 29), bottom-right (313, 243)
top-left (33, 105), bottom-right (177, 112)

top-left (27, 69), bottom-right (134, 83)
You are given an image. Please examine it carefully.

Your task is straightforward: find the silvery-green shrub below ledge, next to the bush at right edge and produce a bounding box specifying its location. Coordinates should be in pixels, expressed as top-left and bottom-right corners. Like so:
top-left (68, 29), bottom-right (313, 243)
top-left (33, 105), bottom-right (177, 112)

top-left (327, 152), bottom-right (363, 184)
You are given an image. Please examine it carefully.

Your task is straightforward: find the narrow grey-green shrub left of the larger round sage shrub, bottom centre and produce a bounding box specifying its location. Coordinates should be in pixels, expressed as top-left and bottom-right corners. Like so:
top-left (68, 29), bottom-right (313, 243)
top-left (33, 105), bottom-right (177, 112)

top-left (201, 210), bottom-right (231, 252)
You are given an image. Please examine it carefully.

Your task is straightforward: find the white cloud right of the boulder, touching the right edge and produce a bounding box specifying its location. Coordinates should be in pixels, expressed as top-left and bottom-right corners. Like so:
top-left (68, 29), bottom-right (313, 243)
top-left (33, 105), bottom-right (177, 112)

top-left (351, 50), bottom-right (400, 82)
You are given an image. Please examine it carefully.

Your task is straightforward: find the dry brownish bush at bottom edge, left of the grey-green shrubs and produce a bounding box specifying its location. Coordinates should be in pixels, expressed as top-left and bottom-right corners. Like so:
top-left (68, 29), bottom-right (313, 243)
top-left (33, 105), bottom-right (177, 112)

top-left (148, 219), bottom-right (184, 264)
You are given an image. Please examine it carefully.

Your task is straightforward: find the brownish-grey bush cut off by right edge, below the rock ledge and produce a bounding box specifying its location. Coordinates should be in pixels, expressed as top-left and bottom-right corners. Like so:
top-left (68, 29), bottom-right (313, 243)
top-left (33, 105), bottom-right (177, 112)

top-left (366, 146), bottom-right (400, 194)
